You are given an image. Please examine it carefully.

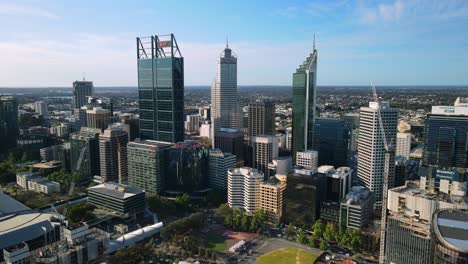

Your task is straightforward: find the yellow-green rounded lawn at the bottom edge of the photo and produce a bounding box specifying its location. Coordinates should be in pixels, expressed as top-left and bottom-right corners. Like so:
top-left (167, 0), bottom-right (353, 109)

top-left (257, 248), bottom-right (317, 264)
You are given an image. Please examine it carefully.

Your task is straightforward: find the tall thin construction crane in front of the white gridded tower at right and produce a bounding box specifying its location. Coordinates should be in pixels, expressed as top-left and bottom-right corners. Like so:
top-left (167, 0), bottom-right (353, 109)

top-left (371, 83), bottom-right (395, 264)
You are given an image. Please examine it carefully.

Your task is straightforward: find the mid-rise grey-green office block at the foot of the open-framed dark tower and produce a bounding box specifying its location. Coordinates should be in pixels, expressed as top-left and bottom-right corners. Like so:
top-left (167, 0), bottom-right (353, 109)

top-left (127, 140), bottom-right (172, 195)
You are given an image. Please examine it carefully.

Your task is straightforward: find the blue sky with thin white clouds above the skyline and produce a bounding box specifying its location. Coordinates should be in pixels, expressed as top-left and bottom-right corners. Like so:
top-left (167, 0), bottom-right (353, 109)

top-left (0, 0), bottom-right (468, 87)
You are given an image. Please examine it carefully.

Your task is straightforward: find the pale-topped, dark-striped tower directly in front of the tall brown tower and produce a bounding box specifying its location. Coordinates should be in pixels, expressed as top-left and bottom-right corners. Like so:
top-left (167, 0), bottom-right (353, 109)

top-left (252, 135), bottom-right (278, 180)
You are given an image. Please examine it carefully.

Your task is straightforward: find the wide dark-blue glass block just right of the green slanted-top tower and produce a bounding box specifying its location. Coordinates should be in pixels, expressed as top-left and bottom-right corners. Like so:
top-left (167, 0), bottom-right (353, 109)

top-left (313, 118), bottom-right (351, 167)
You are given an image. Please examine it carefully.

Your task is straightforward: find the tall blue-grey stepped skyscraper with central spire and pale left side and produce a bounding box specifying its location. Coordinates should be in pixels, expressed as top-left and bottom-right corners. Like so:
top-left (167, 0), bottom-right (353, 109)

top-left (211, 43), bottom-right (241, 142)
